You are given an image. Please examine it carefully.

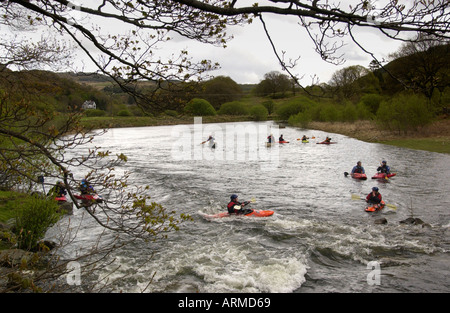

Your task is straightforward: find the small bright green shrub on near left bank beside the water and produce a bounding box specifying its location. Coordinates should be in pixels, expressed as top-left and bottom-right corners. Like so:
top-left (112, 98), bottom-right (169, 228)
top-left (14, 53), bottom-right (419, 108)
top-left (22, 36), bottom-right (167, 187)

top-left (15, 196), bottom-right (59, 250)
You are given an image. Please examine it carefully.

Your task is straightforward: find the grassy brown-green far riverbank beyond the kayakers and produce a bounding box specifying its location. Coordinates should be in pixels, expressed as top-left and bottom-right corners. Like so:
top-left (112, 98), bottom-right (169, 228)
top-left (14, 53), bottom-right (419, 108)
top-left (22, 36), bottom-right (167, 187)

top-left (81, 115), bottom-right (450, 154)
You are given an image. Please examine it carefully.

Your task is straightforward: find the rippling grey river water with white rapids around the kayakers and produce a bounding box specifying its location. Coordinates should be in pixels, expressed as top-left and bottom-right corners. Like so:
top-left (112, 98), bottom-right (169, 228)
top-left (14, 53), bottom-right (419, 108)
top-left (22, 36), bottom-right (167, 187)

top-left (47, 120), bottom-right (450, 293)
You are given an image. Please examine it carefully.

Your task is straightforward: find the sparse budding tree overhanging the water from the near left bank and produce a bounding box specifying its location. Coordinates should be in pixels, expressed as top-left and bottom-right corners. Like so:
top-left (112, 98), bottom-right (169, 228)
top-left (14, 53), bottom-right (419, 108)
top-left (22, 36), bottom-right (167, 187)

top-left (0, 70), bottom-right (189, 291)
